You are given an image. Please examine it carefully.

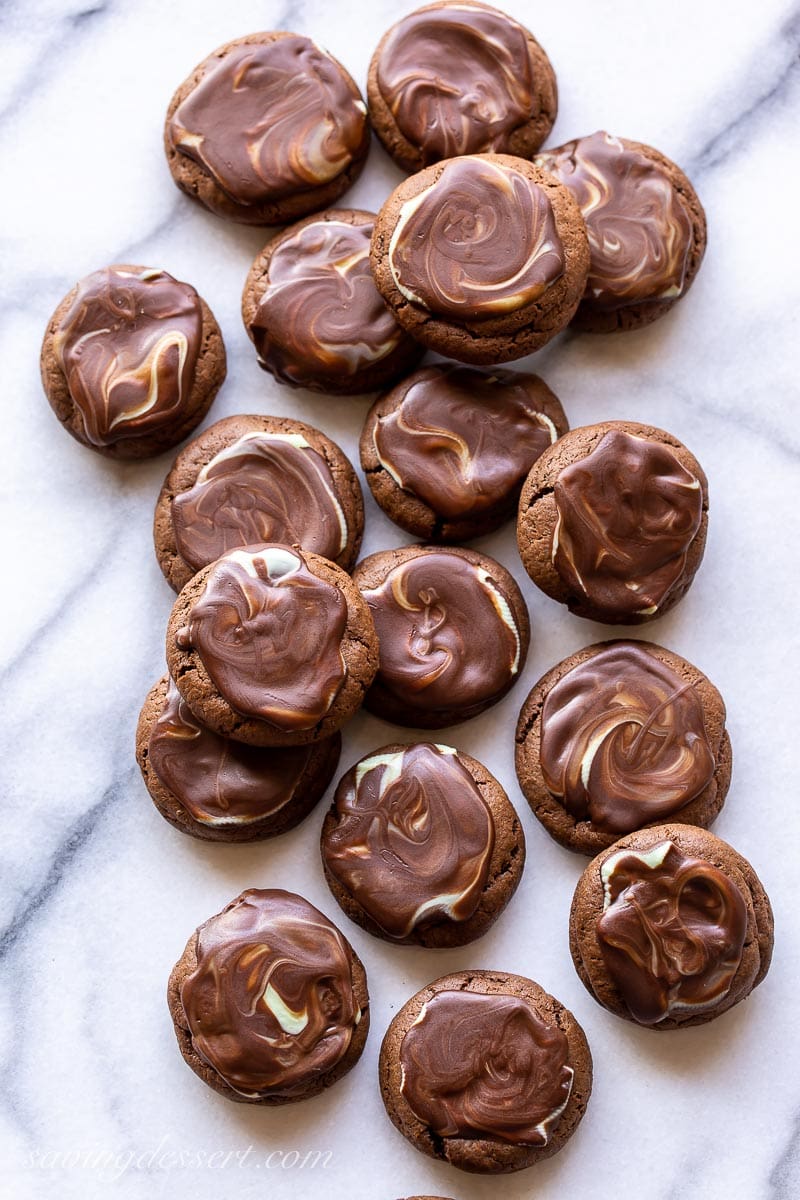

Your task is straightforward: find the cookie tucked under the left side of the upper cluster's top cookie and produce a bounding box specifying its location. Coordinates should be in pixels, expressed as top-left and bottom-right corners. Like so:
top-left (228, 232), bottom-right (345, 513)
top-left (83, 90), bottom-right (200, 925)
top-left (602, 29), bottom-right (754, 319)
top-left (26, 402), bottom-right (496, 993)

top-left (242, 209), bottom-right (423, 396)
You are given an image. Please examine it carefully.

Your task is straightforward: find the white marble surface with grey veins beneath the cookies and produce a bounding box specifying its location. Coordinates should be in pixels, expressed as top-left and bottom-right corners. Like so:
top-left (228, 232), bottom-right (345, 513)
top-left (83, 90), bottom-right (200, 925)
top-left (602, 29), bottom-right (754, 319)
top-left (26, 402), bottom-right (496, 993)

top-left (0, 0), bottom-right (800, 1200)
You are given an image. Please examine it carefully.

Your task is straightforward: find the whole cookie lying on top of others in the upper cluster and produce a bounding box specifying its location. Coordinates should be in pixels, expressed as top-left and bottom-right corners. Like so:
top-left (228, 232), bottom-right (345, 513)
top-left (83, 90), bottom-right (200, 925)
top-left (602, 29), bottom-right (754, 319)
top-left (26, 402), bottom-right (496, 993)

top-left (372, 155), bottom-right (589, 364)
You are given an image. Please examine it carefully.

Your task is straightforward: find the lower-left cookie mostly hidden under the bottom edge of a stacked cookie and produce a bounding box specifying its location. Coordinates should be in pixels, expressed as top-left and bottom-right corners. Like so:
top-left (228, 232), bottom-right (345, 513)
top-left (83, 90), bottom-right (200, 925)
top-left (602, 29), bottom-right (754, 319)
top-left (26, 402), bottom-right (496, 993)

top-left (136, 676), bottom-right (342, 841)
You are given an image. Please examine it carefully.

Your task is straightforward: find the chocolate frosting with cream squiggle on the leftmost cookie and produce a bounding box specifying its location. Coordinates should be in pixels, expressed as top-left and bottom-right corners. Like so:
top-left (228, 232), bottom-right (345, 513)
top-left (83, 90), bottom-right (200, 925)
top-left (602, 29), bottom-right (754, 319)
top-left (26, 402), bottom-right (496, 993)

top-left (54, 266), bottom-right (203, 446)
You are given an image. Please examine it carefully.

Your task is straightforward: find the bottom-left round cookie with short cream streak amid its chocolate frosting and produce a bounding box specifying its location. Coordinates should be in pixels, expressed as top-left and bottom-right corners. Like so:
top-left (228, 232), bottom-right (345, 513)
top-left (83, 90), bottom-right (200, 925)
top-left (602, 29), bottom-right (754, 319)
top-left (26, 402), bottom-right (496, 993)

top-left (167, 888), bottom-right (369, 1105)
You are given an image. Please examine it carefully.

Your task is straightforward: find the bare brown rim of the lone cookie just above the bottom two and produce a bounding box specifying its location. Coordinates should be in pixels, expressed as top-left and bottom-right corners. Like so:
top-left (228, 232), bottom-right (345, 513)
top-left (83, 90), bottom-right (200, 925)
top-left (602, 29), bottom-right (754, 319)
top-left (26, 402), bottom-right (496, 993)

top-left (321, 743), bottom-right (525, 949)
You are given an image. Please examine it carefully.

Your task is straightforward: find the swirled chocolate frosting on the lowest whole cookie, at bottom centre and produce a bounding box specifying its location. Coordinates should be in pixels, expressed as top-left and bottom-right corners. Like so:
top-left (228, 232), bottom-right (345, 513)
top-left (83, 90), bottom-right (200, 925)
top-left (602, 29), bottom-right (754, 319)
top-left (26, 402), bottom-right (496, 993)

top-left (399, 991), bottom-right (573, 1146)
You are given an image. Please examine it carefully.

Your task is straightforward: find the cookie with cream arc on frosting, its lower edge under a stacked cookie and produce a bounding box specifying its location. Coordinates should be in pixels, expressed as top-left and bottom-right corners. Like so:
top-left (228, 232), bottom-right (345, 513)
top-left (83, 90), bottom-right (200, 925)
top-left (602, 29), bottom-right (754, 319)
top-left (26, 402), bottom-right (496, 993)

top-left (154, 416), bottom-right (363, 592)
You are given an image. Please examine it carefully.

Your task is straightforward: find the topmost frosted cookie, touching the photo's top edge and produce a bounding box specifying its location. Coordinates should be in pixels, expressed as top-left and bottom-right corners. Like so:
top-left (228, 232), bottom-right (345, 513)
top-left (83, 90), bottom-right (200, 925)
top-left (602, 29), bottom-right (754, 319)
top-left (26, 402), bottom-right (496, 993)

top-left (367, 0), bottom-right (558, 172)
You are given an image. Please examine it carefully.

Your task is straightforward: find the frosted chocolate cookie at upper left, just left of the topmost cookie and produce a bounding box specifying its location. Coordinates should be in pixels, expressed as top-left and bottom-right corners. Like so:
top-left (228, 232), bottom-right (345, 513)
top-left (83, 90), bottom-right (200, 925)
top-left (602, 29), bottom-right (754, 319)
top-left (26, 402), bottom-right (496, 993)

top-left (164, 32), bottom-right (369, 226)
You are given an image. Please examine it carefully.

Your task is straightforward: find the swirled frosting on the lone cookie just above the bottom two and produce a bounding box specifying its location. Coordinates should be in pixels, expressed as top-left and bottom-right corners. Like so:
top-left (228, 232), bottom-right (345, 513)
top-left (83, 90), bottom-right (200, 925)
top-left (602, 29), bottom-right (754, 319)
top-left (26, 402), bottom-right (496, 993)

top-left (323, 743), bottom-right (494, 937)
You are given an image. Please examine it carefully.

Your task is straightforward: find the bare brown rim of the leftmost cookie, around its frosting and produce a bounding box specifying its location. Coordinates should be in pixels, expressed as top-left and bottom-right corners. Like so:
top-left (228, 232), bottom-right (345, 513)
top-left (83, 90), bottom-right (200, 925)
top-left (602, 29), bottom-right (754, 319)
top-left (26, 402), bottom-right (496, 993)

top-left (40, 263), bottom-right (227, 460)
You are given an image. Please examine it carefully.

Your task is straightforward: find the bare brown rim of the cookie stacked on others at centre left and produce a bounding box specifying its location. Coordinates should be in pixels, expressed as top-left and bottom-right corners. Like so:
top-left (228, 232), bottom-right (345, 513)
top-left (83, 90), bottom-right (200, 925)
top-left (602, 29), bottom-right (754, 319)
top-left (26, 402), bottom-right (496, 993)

top-left (167, 551), bottom-right (378, 746)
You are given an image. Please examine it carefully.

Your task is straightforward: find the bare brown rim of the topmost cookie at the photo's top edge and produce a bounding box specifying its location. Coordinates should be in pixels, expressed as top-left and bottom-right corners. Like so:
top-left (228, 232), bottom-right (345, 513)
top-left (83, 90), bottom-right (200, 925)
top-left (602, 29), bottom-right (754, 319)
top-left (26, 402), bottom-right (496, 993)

top-left (367, 0), bottom-right (558, 174)
